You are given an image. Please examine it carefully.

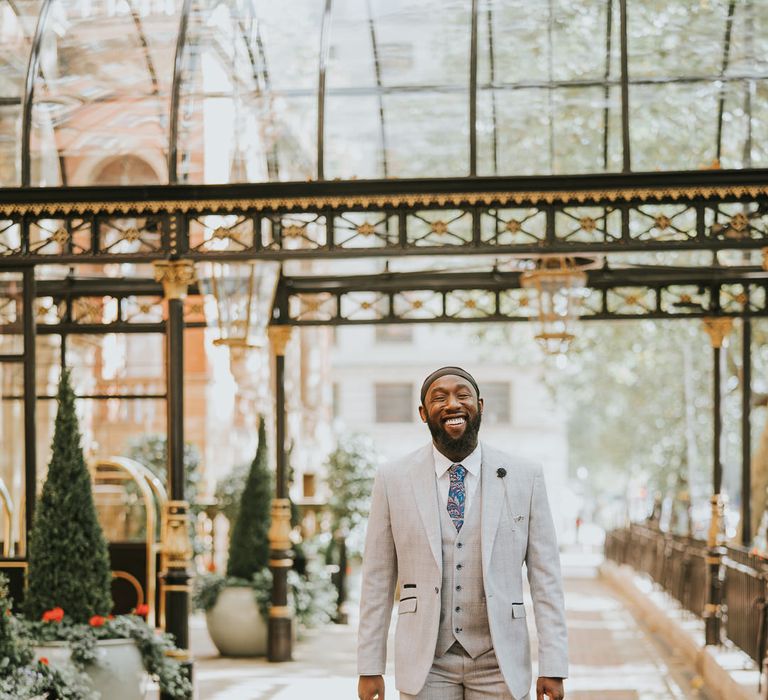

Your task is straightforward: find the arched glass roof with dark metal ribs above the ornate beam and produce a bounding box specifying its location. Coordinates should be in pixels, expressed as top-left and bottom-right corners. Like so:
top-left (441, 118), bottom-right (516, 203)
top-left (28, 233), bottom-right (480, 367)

top-left (0, 0), bottom-right (768, 186)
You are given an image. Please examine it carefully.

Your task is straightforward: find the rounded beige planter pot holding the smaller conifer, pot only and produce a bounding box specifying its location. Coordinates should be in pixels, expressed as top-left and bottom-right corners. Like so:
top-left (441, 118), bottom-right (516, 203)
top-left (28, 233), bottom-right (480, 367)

top-left (205, 586), bottom-right (267, 656)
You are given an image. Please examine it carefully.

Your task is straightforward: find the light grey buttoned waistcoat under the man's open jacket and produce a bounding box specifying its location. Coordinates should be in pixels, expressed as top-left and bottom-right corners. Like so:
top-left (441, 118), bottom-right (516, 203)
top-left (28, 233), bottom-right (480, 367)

top-left (435, 472), bottom-right (493, 659)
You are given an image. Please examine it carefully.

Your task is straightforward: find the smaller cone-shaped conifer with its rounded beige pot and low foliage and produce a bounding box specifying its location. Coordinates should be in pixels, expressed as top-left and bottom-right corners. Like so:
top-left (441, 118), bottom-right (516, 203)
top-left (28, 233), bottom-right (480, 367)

top-left (195, 419), bottom-right (272, 656)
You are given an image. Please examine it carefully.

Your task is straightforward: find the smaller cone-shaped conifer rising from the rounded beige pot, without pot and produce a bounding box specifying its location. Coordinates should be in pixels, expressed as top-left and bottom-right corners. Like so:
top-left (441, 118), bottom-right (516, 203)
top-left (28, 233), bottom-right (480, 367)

top-left (227, 418), bottom-right (272, 580)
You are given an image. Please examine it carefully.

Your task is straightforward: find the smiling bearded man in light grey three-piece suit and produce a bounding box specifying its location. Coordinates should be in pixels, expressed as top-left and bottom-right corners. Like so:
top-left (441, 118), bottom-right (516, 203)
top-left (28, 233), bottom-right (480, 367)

top-left (358, 367), bottom-right (568, 700)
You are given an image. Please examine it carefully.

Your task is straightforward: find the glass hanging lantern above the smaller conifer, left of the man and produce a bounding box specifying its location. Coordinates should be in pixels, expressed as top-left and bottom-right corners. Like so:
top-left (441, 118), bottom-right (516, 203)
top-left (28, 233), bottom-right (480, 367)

top-left (200, 260), bottom-right (280, 348)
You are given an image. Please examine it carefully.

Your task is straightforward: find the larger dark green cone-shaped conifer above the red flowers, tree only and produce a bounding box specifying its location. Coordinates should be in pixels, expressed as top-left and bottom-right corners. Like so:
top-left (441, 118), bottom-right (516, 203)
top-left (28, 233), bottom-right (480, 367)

top-left (25, 370), bottom-right (112, 623)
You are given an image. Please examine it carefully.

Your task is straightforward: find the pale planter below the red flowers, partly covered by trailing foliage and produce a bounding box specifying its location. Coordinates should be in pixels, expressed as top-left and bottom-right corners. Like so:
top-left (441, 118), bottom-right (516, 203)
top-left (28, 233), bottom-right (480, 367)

top-left (35, 639), bottom-right (149, 700)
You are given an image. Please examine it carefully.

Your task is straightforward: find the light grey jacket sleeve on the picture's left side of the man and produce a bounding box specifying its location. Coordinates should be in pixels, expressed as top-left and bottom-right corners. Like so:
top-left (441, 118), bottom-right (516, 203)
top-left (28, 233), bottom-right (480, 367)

top-left (357, 470), bottom-right (397, 676)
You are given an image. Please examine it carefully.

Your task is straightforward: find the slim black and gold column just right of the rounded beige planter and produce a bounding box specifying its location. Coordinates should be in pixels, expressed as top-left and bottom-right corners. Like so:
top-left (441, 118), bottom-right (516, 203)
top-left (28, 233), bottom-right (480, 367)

top-left (267, 326), bottom-right (293, 661)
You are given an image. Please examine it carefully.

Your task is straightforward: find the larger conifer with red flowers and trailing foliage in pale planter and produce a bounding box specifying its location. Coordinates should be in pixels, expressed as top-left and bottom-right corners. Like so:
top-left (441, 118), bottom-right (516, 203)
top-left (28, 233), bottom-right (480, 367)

top-left (18, 370), bottom-right (191, 700)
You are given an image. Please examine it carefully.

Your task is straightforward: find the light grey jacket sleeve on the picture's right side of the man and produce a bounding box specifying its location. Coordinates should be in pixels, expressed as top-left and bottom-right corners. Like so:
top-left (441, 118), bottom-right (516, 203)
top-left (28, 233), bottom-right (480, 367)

top-left (526, 467), bottom-right (568, 678)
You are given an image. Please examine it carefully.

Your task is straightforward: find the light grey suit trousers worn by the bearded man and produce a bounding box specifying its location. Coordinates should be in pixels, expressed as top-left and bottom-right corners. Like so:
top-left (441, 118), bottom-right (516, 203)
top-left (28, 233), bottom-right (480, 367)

top-left (400, 642), bottom-right (529, 700)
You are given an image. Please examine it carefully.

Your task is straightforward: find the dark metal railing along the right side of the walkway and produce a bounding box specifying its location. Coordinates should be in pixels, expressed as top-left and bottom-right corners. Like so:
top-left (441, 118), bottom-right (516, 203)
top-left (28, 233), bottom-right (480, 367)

top-left (605, 524), bottom-right (768, 666)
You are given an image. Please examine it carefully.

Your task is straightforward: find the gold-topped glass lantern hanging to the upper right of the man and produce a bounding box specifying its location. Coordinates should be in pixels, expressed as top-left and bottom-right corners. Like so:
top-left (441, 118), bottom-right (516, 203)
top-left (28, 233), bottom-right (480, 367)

top-left (520, 255), bottom-right (594, 355)
